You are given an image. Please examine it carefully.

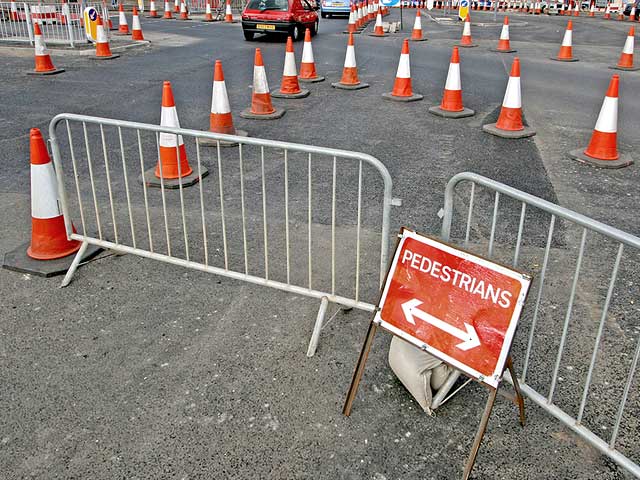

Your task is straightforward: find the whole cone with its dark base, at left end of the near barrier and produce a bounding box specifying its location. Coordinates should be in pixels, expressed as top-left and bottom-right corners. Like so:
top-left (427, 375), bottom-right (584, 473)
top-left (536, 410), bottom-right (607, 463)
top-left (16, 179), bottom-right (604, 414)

top-left (2, 128), bottom-right (102, 277)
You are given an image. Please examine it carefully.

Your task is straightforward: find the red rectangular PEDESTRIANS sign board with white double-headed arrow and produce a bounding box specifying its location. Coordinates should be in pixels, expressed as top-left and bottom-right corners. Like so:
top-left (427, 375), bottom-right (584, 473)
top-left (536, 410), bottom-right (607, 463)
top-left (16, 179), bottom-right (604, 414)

top-left (374, 229), bottom-right (531, 388)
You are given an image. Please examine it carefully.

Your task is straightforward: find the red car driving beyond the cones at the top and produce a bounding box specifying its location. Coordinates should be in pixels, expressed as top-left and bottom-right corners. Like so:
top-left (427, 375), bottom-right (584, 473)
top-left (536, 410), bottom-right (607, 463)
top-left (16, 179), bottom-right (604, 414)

top-left (242, 0), bottom-right (320, 40)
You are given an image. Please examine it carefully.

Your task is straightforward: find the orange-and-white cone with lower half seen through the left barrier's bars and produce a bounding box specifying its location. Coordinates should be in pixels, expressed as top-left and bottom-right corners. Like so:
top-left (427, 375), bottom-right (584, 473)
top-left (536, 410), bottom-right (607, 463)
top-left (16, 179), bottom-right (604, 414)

top-left (142, 81), bottom-right (209, 188)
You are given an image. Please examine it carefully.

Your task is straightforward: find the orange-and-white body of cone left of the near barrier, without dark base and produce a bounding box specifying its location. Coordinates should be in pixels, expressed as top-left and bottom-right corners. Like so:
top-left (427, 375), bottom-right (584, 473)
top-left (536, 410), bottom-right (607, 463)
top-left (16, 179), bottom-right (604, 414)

top-left (27, 127), bottom-right (80, 260)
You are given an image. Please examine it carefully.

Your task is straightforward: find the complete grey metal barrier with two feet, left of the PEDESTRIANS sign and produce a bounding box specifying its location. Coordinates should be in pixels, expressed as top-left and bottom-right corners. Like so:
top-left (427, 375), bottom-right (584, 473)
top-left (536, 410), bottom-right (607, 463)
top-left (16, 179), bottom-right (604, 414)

top-left (49, 114), bottom-right (398, 356)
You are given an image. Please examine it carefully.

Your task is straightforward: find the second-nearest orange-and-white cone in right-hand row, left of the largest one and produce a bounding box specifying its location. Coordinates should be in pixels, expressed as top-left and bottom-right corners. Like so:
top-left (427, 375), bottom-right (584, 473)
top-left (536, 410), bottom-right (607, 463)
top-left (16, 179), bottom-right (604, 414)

top-left (482, 57), bottom-right (536, 138)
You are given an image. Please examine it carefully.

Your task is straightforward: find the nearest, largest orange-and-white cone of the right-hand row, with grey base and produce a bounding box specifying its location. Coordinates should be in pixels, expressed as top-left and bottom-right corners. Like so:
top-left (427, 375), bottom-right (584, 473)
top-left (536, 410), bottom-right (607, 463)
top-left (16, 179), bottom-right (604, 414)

top-left (569, 75), bottom-right (633, 168)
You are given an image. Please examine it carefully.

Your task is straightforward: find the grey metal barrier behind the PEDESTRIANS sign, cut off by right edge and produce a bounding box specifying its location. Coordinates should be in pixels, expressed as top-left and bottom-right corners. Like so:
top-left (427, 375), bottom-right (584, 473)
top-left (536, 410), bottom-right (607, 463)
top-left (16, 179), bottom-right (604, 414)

top-left (432, 173), bottom-right (640, 477)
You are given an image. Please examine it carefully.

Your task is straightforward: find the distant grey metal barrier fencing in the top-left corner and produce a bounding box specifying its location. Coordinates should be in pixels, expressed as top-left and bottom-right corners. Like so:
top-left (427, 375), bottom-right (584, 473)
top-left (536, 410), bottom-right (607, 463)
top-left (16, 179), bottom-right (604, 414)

top-left (0, 2), bottom-right (87, 47)
